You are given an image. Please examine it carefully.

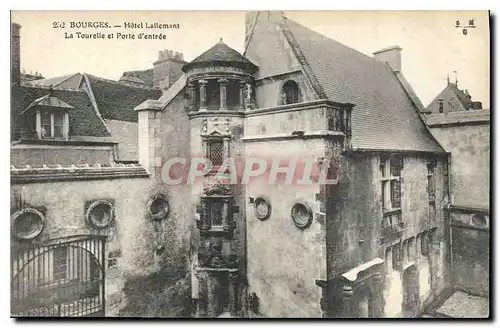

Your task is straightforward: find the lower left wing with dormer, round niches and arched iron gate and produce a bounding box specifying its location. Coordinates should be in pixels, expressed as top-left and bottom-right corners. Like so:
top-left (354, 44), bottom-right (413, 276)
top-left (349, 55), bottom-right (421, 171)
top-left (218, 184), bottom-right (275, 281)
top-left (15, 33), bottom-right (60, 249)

top-left (10, 24), bottom-right (193, 316)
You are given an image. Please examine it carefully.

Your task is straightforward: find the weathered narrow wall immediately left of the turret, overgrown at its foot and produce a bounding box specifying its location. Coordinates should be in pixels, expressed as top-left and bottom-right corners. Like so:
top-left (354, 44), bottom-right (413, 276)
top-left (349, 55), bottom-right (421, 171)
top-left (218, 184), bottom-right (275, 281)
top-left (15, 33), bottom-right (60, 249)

top-left (134, 92), bottom-right (195, 317)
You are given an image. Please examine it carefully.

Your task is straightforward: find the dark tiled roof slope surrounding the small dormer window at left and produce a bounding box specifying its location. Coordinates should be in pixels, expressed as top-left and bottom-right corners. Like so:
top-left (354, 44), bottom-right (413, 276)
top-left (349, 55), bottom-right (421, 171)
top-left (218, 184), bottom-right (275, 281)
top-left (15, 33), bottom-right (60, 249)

top-left (11, 86), bottom-right (109, 139)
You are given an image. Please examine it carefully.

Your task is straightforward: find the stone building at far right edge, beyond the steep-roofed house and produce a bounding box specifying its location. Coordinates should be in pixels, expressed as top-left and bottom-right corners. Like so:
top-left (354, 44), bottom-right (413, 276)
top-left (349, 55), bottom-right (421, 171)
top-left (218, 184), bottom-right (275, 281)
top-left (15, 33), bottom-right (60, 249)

top-left (425, 81), bottom-right (491, 311)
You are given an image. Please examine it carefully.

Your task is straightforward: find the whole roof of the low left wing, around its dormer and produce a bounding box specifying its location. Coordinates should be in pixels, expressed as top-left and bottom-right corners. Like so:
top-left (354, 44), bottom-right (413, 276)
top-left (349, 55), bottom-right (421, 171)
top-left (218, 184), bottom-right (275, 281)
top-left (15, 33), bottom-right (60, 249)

top-left (11, 73), bottom-right (161, 161)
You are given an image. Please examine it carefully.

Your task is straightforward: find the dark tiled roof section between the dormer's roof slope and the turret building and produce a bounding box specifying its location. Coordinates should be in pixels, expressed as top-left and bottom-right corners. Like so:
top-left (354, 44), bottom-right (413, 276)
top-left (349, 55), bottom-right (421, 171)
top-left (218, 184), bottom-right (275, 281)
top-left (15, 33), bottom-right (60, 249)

top-left (86, 74), bottom-right (161, 122)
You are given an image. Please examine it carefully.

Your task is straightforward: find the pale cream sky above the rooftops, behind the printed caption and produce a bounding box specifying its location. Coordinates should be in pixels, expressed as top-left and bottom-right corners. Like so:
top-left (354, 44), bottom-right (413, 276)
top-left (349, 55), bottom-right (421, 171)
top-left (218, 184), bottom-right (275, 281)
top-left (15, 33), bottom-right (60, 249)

top-left (11, 11), bottom-right (490, 108)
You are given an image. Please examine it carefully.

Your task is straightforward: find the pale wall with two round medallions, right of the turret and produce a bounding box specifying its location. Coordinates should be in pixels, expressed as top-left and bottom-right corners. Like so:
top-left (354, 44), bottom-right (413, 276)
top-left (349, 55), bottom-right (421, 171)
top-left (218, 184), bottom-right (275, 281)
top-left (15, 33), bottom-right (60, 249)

top-left (245, 139), bottom-right (326, 318)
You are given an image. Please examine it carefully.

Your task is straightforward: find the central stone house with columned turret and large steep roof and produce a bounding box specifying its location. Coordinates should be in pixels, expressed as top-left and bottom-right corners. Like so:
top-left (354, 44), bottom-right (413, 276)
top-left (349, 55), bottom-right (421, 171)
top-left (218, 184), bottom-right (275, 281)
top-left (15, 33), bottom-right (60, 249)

top-left (136, 12), bottom-right (450, 317)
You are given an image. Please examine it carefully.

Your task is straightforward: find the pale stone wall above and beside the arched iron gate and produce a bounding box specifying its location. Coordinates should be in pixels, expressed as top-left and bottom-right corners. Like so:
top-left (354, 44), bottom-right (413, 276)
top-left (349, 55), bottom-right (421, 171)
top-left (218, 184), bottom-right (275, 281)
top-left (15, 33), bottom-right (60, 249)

top-left (11, 179), bottom-right (149, 316)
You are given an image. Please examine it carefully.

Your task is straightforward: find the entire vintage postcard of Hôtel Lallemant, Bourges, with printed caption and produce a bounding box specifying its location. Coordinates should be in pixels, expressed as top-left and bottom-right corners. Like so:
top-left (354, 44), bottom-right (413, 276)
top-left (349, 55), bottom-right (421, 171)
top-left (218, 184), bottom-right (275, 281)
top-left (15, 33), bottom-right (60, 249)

top-left (10, 11), bottom-right (491, 319)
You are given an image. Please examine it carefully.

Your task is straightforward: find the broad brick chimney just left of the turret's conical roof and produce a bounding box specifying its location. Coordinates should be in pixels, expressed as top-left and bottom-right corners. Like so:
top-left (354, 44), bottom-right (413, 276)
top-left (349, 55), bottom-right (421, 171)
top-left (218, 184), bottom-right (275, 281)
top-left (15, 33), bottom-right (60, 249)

top-left (153, 49), bottom-right (186, 90)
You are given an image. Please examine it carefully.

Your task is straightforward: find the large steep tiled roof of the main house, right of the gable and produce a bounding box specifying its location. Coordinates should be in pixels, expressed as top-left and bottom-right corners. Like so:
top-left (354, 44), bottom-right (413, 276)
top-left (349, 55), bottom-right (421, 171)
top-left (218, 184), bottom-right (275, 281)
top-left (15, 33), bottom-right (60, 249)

top-left (283, 16), bottom-right (444, 152)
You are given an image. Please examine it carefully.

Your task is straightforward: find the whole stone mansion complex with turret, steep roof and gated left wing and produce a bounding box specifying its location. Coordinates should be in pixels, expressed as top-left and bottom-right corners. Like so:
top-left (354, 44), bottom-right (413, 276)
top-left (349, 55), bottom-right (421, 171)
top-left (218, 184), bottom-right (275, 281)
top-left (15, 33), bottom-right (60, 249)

top-left (11, 12), bottom-right (490, 318)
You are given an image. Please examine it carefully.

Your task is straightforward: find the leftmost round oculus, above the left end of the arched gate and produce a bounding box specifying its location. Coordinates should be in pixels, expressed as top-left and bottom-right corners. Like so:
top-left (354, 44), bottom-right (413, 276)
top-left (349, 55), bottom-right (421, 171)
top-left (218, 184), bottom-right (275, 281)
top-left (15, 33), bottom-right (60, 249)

top-left (12, 208), bottom-right (45, 240)
